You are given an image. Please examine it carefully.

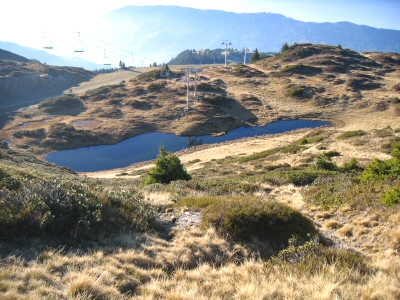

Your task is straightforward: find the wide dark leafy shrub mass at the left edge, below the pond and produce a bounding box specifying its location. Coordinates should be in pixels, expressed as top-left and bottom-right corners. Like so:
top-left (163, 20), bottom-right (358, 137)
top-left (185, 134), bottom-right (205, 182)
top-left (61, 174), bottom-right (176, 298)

top-left (0, 172), bottom-right (156, 243)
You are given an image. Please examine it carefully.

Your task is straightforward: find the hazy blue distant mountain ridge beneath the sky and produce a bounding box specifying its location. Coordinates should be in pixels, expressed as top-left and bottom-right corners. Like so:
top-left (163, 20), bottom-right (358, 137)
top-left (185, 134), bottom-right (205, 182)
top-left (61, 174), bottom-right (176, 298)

top-left (89, 6), bottom-right (400, 62)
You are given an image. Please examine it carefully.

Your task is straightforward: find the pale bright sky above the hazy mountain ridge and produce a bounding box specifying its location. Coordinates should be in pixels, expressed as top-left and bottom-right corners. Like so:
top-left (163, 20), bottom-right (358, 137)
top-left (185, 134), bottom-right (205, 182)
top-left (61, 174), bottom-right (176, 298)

top-left (0, 0), bottom-right (400, 61)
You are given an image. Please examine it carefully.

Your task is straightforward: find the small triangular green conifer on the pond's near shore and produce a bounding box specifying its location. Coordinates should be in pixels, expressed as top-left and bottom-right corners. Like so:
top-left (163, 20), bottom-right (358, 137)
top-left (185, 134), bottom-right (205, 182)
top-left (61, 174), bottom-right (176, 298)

top-left (144, 146), bottom-right (191, 184)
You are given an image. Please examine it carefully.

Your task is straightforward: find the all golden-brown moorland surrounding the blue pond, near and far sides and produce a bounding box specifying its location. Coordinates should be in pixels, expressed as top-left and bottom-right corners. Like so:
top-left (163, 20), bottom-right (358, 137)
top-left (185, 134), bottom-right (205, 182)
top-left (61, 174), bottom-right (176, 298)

top-left (0, 44), bottom-right (400, 299)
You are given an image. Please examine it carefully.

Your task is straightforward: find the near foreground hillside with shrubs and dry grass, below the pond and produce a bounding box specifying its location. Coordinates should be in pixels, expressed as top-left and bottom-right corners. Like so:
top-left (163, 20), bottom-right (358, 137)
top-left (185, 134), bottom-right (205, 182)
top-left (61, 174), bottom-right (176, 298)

top-left (0, 94), bottom-right (400, 300)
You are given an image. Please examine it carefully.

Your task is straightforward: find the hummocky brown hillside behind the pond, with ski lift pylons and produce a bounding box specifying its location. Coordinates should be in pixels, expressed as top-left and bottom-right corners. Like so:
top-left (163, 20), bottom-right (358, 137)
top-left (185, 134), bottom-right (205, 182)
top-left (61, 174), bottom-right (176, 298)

top-left (1, 44), bottom-right (400, 157)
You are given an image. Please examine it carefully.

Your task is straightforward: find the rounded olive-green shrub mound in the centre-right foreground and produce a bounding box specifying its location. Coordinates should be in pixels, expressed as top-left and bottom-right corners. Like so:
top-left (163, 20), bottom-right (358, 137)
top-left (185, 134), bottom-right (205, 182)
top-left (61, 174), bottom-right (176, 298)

top-left (178, 197), bottom-right (316, 250)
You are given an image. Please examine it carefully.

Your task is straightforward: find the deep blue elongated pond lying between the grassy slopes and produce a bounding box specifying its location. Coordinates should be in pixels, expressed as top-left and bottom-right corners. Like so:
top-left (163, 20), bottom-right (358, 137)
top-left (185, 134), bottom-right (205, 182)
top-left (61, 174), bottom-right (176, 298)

top-left (46, 120), bottom-right (330, 172)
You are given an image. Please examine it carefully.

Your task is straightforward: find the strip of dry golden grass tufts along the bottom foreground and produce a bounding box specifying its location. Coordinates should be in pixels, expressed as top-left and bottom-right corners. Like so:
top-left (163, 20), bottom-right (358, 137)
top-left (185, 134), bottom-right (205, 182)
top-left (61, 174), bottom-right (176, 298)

top-left (0, 239), bottom-right (400, 299)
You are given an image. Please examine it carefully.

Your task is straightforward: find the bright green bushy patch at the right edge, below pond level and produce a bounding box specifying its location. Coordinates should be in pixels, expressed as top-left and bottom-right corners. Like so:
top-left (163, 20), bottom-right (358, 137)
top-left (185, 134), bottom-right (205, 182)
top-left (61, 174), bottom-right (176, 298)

top-left (305, 144), bottom-right (400, 209)
